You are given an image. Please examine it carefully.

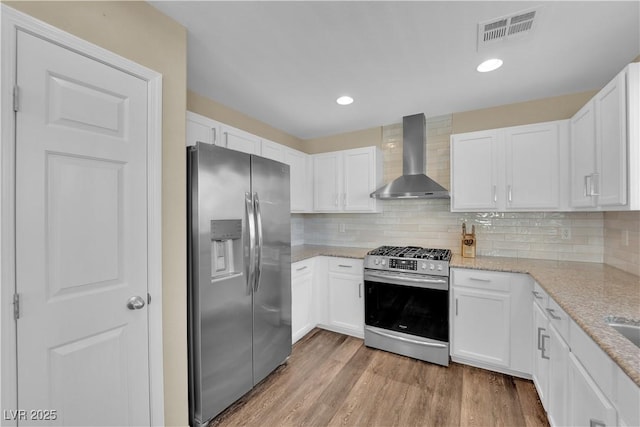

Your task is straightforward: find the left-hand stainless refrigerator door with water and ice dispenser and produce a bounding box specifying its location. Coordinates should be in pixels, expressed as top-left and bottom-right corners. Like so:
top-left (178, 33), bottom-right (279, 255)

top-left (188, 143), bottom-right (253, 425)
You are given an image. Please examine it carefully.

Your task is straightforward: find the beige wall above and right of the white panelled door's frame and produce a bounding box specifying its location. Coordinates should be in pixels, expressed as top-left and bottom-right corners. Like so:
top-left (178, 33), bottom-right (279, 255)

top-left (5, 1), bottom-right (188, 425)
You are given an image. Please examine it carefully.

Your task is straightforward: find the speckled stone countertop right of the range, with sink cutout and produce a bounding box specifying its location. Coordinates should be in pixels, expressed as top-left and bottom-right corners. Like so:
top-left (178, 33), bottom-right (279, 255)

top-left (449, 255), bottom-right (640, 386)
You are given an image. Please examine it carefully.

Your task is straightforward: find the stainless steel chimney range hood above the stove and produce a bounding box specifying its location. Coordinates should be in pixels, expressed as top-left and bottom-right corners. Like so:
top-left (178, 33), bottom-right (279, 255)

top-left (371, 113), bottom-right (449, 199)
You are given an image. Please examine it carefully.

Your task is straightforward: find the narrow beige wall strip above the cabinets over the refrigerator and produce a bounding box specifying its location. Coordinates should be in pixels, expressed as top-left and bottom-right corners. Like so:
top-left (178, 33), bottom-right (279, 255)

top-left (187, 91), bottom-right (304, 151)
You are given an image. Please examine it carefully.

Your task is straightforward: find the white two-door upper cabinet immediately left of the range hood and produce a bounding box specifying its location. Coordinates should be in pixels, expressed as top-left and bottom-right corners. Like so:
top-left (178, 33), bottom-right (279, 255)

top-left (313, 147), bottom-right (382, 212)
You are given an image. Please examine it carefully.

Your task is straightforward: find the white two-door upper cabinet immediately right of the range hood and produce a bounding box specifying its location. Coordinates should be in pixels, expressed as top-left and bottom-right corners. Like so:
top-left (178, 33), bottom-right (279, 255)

top-left (451, 120), bottom-right (568, 211)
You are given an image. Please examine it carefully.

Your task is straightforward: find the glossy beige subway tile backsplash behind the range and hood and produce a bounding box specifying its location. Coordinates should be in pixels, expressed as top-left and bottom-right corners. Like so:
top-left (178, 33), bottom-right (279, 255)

top-left (292, 115), bottom-right (640, 274)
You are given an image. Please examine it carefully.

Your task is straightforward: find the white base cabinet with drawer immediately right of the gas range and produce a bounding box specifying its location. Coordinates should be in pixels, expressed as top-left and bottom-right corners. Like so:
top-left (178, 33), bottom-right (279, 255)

top-left (451, 268), bottom-right (532, 377)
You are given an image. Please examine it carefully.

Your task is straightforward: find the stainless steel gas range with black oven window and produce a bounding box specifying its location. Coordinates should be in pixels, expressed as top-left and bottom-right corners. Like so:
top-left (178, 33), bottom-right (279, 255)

top-left (364, 246), bottom-right (451, 366)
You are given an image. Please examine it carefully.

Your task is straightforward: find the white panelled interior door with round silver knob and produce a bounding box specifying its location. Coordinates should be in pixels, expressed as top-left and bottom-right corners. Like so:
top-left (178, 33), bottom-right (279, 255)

top-left (16, 31), bottom-right (150, 425)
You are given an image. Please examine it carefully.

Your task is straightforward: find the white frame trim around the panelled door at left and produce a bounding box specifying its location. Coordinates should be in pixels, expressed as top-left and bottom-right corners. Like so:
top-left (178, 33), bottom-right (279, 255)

top-left (0, 4), bottom-right (164, 426)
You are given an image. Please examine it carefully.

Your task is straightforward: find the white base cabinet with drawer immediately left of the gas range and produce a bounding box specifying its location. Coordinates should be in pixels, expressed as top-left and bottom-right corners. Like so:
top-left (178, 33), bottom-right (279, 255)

top-left (327, 257), bottom-right (364, 338)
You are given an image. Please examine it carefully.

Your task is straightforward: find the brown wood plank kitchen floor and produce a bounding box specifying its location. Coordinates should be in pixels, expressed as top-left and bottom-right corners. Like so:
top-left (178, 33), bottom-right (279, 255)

top-left (209, 329), bottom-right (548, 427)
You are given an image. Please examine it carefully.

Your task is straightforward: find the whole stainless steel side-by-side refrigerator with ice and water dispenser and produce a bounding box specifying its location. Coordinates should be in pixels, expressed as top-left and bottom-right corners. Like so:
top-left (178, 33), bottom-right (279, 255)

top-left (187, 143), bottom-right (291, 426)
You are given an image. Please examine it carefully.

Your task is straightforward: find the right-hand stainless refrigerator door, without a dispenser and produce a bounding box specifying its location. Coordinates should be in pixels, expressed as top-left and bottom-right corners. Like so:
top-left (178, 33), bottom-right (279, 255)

top-left (251, 156), bottom-right (291, 384)
